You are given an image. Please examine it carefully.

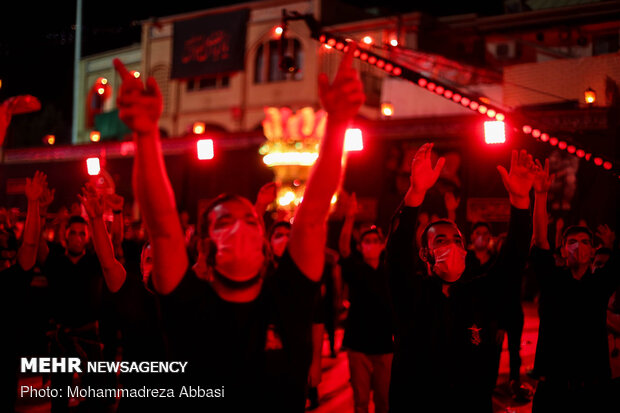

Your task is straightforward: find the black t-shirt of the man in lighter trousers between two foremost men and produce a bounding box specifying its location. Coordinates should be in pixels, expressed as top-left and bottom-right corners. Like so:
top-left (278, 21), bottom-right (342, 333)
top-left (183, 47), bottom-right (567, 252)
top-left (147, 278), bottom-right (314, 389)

top-left (340, 254), bottom-right (394, 354)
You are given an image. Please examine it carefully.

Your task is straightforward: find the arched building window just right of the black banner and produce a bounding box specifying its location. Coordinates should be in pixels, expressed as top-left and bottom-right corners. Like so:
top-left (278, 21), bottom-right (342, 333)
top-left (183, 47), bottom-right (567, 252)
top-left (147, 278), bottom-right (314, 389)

top-left (254, 39), bottom-right (304, 83)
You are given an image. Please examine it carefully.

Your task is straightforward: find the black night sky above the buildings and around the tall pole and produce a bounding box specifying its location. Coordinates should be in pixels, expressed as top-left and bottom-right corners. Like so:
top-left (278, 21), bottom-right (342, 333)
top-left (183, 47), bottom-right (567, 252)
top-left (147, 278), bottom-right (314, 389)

top-left (0, 0), bottom-right (503, 148)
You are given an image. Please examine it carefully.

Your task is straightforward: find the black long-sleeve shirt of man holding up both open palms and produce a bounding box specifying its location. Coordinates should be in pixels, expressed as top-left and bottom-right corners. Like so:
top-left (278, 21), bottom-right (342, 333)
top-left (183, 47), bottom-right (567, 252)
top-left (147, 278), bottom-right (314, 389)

top-left (387, 207), bottom-right (531, 412)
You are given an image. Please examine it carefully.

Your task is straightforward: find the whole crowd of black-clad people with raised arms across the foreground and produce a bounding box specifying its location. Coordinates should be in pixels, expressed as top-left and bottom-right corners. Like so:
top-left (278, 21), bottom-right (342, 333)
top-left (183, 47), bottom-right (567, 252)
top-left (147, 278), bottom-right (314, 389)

top-left (0, 43), bottom-right (620, 413)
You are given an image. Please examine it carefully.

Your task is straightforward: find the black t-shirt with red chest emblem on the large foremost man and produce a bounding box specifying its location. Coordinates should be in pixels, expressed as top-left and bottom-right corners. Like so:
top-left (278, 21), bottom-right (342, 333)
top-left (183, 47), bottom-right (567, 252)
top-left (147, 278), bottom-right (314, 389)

top-left (161, 251), bottom-right (319, 412)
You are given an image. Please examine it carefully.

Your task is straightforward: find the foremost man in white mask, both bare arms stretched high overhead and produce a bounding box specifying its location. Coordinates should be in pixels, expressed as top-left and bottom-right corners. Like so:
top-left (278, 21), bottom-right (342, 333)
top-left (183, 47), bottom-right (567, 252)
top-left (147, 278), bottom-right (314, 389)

top-left (114, 42), bottom-right (365, 413)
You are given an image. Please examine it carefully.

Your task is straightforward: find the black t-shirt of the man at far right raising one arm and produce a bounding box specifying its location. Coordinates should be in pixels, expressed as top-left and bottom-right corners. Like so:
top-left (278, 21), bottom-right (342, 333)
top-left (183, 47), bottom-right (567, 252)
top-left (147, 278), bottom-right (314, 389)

top-left (530, 247), bottom-right (620, 381)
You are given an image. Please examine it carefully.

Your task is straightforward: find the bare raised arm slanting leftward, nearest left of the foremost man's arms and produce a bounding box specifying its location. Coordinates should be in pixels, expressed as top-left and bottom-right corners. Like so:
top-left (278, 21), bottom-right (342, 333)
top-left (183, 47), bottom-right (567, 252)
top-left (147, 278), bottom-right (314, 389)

top-left (78, 184), bottom-right (127, 293)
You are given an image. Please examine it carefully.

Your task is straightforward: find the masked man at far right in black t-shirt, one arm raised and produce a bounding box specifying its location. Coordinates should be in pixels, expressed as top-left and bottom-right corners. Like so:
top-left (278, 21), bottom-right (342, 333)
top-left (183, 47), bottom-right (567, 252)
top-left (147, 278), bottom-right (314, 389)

top-left (531, 161), bottom-right (620, 413)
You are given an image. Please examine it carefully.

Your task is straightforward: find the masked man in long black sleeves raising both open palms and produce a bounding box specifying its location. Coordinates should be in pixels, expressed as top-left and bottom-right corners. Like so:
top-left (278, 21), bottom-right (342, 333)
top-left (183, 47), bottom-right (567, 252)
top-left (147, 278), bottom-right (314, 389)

top-left (387, 144), bottom-right (535, 413)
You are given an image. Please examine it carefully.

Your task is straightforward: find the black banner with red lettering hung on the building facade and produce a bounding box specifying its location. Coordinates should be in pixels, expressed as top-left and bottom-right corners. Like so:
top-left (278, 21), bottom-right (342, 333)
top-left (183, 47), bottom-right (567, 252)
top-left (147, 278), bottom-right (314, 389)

top-left (172, 9), bottom-right (250, 79)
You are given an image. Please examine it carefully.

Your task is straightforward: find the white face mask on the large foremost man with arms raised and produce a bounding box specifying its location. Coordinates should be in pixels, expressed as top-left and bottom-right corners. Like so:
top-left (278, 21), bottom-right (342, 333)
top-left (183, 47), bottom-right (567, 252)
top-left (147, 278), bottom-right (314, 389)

top-left (211, 220), bottom-right (265, 282)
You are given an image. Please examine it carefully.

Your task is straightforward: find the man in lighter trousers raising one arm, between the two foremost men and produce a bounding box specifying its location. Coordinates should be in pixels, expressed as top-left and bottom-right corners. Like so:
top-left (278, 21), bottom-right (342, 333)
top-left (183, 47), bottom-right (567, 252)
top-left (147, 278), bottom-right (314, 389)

top-left (339, 194), bottom-right (394, 413)
